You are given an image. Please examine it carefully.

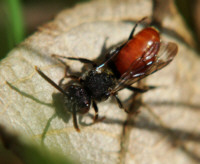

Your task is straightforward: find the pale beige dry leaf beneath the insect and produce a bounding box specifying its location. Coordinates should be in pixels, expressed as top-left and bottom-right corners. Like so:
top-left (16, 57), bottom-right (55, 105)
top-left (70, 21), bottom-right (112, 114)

top-left (0, 0), bottom-right (200, 164)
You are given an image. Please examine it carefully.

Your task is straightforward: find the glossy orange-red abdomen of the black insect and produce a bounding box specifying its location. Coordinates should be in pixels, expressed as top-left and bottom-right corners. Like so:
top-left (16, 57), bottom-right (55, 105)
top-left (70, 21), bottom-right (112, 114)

top-left (114, 27), bottom-right (160, 75)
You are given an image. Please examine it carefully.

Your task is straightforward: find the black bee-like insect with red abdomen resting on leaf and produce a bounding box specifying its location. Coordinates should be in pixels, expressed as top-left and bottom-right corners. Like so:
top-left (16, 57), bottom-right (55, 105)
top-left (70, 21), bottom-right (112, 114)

top-left (35, 19), bottom-right (178, 132)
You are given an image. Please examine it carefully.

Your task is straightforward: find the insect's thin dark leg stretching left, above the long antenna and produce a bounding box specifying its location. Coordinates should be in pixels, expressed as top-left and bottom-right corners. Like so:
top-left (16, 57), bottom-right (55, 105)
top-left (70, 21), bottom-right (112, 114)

top-left (52, 54), bottom-right (97, 67)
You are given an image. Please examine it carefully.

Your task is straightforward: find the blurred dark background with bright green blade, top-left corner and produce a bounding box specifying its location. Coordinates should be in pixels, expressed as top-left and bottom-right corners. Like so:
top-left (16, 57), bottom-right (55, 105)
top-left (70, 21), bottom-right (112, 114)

top-left (0, 0), bottom-right (89, 60)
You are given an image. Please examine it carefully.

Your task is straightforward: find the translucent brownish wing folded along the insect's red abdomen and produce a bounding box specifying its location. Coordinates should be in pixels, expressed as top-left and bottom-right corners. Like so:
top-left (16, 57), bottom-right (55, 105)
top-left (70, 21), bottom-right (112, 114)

top-left (111, 42), bottom-right (178, 93)
